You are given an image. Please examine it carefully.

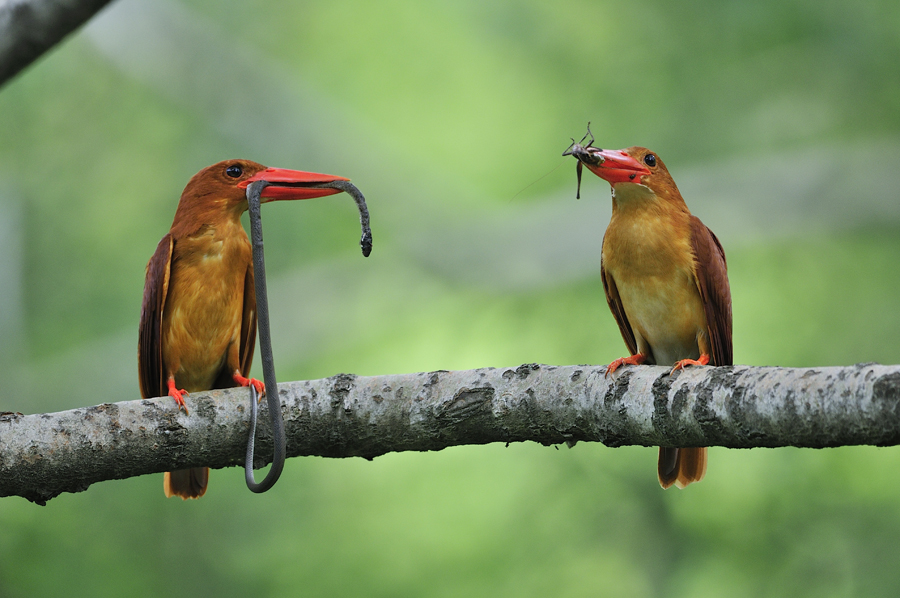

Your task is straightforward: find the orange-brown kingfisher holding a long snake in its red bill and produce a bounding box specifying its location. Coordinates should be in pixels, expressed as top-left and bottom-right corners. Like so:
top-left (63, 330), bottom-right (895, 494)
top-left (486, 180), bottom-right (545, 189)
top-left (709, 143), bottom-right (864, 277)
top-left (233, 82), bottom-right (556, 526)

top-left (138, 160), bottom-right (348, 500)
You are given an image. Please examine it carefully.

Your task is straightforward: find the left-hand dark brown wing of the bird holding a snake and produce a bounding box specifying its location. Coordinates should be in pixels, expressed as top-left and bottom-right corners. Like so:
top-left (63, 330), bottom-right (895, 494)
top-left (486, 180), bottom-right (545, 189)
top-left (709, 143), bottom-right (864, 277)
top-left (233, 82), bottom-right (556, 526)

top-left (138, 234), bottom-right (174, 399)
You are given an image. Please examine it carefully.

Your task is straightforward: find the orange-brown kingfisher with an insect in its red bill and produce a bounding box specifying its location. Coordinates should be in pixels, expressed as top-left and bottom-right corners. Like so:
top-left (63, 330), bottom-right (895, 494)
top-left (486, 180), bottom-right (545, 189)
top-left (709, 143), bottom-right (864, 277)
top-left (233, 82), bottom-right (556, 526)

top-left (564, 141), bottom-right (733, 488)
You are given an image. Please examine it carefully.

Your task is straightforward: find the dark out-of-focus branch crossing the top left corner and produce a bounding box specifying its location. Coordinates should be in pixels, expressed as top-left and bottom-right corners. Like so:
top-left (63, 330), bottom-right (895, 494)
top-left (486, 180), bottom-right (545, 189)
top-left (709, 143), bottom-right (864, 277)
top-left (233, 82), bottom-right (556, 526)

top-left (0, 0), bottom-right (109, 87)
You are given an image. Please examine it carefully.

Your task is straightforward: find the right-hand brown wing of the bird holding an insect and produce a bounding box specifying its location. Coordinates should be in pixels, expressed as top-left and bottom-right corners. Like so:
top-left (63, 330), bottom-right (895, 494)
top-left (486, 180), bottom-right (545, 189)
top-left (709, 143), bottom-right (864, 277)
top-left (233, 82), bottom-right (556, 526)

top-left (691, 216), bottom-right (734, 365)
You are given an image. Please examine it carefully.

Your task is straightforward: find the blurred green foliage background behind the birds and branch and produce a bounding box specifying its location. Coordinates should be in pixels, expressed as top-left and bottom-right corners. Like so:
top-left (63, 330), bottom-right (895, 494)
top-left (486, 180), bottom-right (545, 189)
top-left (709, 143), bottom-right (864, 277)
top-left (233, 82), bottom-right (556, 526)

top-left (0, 0), bottom-right (900, 598)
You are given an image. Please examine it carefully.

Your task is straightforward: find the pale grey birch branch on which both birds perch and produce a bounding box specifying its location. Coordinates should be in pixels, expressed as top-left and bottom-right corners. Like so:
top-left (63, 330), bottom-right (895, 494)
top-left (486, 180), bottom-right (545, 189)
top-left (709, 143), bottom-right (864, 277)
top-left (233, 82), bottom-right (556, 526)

top-left (0, 364), bottom-right (900, 504)
